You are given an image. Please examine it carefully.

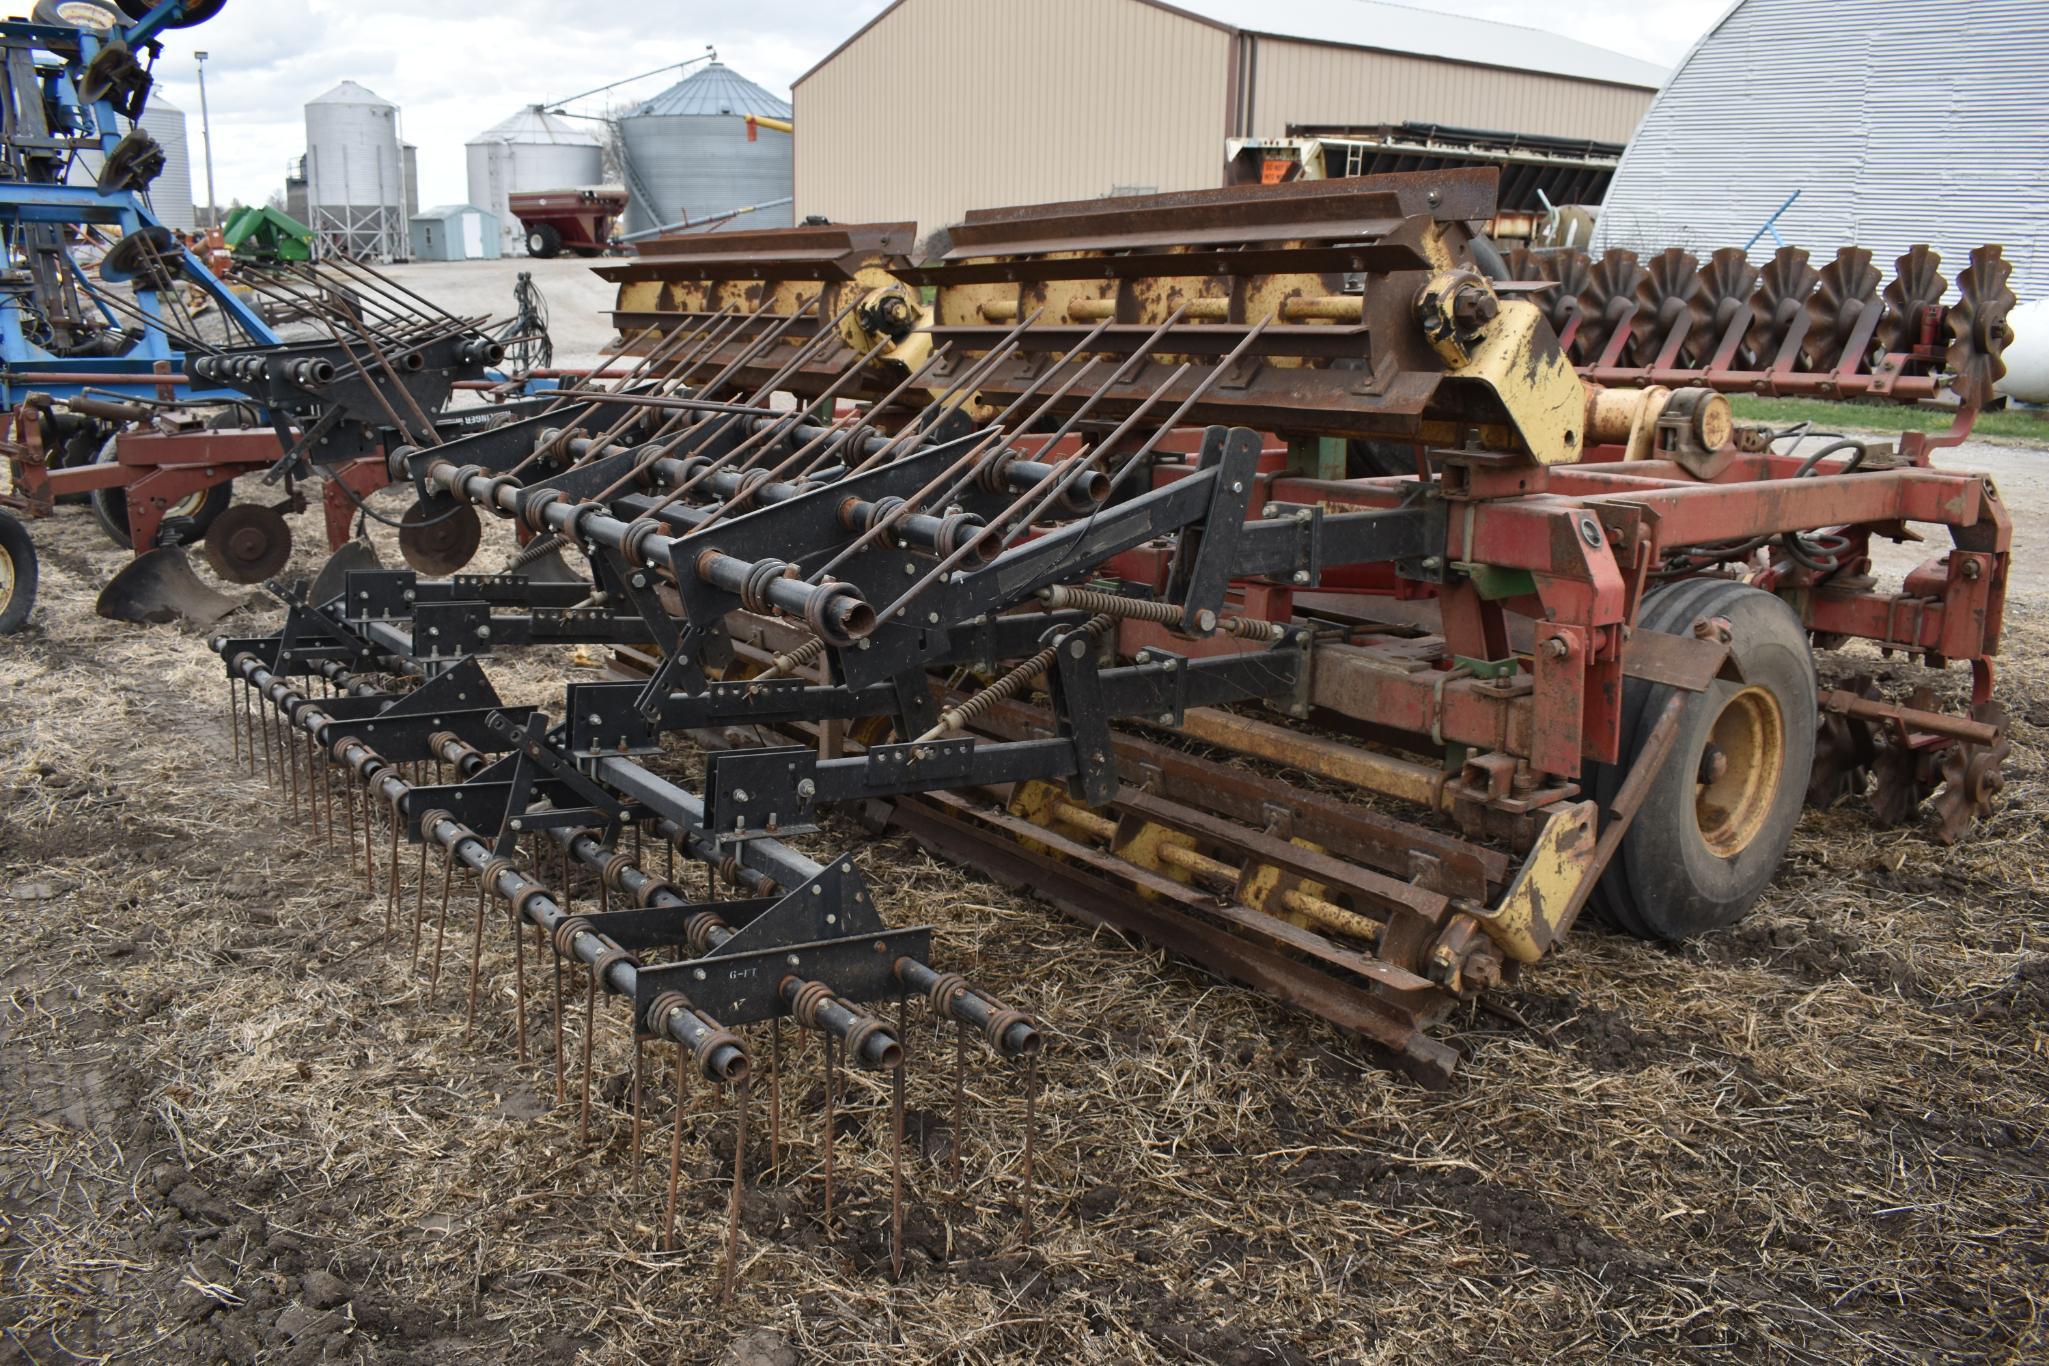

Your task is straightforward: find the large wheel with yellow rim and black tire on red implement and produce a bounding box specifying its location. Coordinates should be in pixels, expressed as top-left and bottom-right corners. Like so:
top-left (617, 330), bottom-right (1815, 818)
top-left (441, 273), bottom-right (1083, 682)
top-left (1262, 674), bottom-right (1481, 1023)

top-left (1590, 580), bottom-right (1817, 940)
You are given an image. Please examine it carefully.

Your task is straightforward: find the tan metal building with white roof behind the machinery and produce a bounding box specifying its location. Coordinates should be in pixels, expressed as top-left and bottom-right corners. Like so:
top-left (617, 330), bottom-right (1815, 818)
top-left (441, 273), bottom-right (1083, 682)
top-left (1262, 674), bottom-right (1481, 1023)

top-left (795, 0), bottom-right (1664, 248)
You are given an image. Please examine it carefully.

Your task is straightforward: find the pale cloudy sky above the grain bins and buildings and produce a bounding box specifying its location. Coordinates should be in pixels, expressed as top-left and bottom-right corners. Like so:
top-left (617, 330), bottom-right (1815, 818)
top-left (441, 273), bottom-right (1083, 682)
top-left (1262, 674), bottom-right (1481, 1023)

top-left (144, 0), bottom-right (1727, 214)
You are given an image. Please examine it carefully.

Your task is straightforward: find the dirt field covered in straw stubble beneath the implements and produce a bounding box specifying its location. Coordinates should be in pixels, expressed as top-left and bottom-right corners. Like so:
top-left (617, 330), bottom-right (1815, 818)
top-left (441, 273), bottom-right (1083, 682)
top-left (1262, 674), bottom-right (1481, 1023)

top-left (0, 428), bottom-right (2049, 1366)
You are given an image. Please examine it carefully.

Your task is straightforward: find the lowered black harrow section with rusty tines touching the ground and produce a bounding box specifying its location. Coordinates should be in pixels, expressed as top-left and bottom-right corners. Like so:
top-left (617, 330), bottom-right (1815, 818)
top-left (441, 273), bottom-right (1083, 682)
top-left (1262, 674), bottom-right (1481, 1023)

top-left (211, 631), bottom-right (1041, 1296)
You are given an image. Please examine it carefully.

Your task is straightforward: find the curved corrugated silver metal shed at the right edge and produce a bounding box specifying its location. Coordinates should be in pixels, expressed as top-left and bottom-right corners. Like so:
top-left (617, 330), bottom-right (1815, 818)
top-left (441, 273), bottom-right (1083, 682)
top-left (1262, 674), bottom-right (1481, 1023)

top-left (1594, 0), bottom-right (2049, 299)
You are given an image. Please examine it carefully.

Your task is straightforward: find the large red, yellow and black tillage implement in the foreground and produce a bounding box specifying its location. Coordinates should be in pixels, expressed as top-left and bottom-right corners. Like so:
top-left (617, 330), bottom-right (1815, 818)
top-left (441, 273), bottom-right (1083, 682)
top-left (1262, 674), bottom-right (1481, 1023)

top-left (215, 174), bottom-right (2012, 1268)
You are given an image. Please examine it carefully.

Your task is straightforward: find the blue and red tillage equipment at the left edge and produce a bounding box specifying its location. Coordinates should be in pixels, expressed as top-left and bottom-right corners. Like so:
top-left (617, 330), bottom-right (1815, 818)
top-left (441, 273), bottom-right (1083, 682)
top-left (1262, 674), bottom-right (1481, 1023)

top-left (0, 0), bottom-right (532, 623)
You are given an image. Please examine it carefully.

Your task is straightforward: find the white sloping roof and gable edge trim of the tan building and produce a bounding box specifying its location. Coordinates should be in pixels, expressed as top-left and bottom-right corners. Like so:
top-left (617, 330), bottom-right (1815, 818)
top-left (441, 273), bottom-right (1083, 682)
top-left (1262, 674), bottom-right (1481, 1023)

top-left (793, 0), bottom-right (1668, 90)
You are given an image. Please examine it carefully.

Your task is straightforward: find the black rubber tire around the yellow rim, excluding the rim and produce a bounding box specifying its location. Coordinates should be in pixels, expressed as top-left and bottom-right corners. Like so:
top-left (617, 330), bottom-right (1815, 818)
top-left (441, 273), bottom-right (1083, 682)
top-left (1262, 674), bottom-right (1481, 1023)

top-left (1588, 580), bottom-right (1817, 940)
